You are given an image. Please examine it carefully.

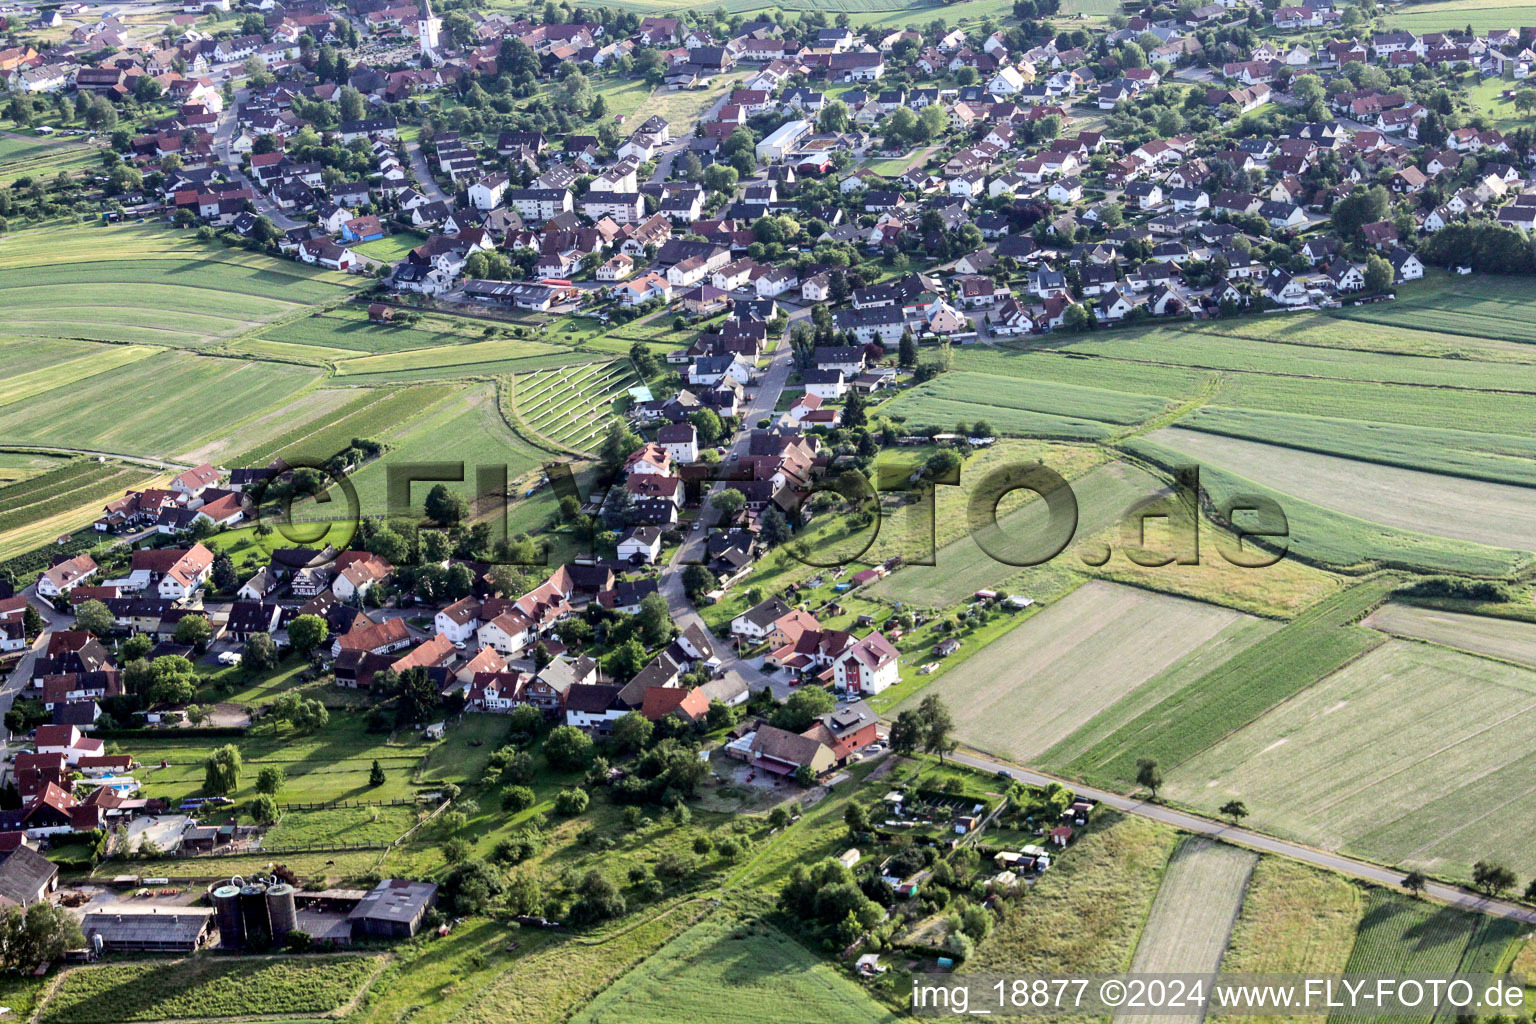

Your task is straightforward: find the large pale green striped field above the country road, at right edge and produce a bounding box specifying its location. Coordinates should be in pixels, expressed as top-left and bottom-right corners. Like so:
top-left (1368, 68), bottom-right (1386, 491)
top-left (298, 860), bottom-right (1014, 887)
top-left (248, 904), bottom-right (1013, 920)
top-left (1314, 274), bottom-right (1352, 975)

top-left (1164, 634), bottom-right (1536, 878)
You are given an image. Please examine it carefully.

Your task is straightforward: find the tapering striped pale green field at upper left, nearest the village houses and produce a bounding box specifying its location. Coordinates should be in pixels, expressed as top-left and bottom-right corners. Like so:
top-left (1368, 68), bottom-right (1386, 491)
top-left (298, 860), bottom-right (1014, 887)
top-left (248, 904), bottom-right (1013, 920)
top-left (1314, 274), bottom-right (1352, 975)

top-left (0, 226), bottom-right (356, 345)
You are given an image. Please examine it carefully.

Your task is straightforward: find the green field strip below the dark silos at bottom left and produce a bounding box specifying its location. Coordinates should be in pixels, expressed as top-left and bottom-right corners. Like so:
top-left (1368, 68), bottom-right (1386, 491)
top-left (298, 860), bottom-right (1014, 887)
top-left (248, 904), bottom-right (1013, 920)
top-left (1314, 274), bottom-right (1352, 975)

top-left (38, 956), bottom-right (384, 1024)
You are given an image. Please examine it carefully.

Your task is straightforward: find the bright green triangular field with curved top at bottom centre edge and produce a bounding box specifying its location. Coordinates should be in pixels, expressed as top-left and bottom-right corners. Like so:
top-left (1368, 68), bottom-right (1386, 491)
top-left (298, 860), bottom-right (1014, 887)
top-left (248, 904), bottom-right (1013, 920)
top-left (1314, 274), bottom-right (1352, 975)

top-left (574, 913), bottom-right (897, 1024)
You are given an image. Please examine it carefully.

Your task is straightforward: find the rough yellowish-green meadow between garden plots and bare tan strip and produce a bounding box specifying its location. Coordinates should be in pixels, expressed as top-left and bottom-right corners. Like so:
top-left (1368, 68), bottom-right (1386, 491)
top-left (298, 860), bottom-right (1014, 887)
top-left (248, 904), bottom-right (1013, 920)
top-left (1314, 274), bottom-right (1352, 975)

top-left (966, 811), bottom-right (1178, 973)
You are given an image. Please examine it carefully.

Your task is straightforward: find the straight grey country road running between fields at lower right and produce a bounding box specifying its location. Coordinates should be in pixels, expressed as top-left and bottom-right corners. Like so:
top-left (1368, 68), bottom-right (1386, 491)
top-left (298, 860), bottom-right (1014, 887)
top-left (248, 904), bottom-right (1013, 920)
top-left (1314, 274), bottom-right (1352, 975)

top-left (951, 752), bottom-right (1536, 924)
